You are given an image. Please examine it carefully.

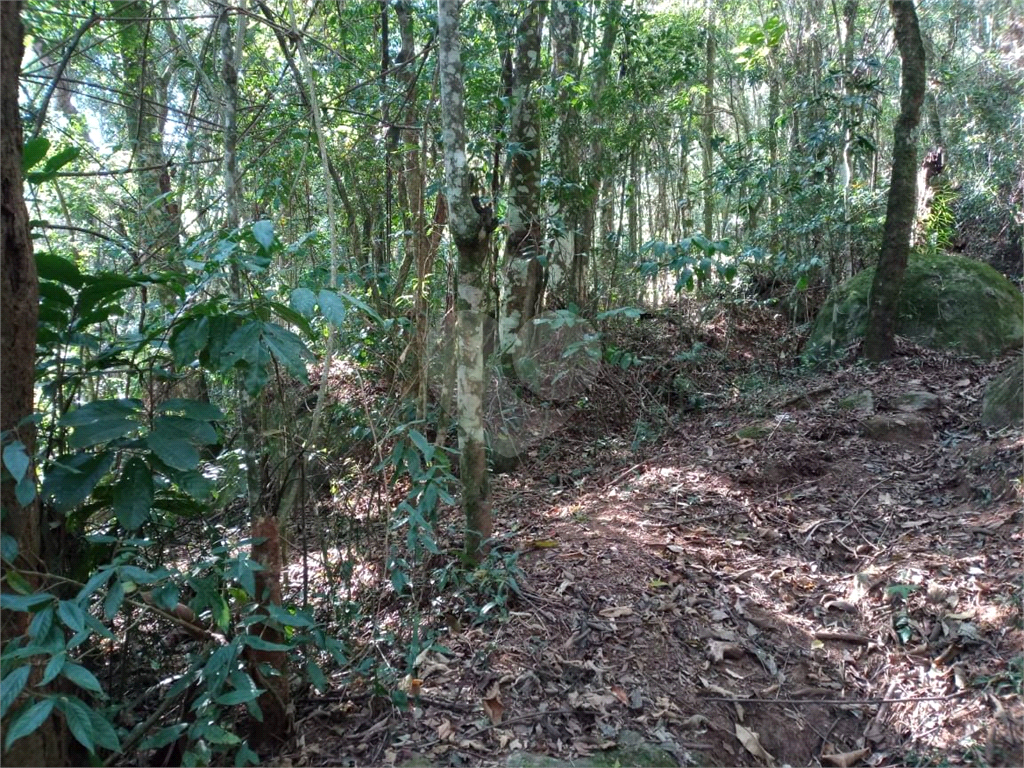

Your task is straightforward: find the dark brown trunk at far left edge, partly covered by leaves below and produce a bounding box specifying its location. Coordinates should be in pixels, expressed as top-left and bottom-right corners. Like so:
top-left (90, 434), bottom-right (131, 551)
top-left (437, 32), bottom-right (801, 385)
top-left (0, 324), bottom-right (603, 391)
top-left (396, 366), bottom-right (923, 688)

top-left (0, 0), bottom-right (69, 766)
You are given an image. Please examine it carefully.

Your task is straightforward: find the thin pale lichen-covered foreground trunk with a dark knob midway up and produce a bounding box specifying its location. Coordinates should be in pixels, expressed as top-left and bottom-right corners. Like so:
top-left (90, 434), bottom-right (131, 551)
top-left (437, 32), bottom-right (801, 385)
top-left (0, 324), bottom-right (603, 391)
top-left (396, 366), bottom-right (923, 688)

top-left (437, 0), bottom-right (495, 562)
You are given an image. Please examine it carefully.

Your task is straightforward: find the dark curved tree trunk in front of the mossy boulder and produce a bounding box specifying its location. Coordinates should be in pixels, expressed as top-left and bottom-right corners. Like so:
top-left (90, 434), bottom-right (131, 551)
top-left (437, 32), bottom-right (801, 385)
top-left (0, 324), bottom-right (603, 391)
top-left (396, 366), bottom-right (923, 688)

top-left (864, 0), bottom-right (925, 361)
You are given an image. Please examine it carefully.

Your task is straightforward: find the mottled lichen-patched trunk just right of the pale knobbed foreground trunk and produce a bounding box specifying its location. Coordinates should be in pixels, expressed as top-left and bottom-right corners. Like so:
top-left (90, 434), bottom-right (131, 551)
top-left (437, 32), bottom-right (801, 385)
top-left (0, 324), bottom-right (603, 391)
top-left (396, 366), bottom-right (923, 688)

top-left (498, 0), bottom-right (547, 352)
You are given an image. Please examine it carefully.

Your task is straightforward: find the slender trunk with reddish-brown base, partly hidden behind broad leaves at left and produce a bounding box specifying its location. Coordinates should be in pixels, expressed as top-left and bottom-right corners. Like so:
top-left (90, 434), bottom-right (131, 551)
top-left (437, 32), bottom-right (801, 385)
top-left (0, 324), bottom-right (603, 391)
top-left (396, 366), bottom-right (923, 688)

top-left (218, 6), bottom-right (292, 750)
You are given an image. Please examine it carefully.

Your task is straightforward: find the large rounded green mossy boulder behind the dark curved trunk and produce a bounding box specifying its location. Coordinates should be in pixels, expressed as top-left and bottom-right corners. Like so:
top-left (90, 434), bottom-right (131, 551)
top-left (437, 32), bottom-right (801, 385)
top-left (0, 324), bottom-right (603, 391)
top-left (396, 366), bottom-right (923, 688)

top-left (804, 254), bottom-right (1024, 361)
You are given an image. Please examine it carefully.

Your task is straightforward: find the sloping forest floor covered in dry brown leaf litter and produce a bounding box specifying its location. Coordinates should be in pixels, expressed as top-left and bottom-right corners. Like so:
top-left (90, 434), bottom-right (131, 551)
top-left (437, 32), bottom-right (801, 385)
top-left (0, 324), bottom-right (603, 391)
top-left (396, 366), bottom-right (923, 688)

top-left (280, 307), bottom-right (1024, 766)
